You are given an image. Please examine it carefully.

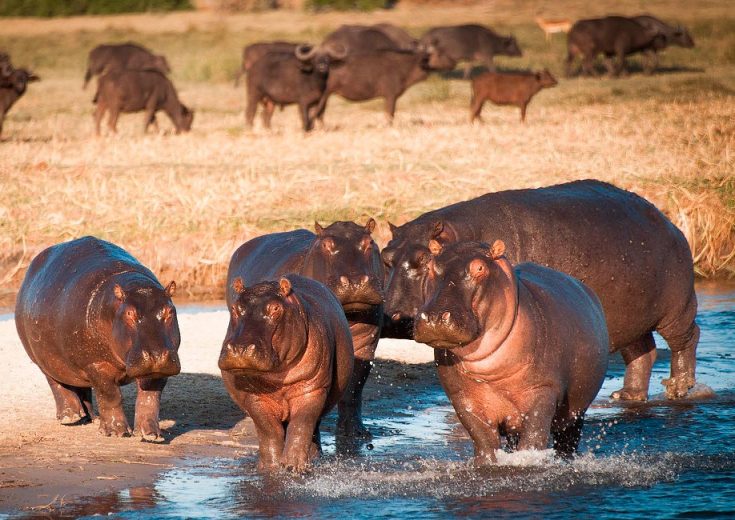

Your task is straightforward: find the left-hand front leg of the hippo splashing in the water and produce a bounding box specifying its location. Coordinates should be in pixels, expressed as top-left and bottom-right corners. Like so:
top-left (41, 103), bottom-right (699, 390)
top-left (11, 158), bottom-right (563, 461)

top-left (434, 350), bottom-right (500, 466)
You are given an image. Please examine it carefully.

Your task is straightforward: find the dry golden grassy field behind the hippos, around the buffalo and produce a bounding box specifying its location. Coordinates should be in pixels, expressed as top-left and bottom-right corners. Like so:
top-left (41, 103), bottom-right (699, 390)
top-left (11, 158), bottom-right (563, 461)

top-left (0, 0), bottom-right (735, 305)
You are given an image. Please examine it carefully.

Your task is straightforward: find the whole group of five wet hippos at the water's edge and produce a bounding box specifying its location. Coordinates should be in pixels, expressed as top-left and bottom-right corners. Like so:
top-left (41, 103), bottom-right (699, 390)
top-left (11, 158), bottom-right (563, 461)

top-left (15, 180), bottom-right (699, 472)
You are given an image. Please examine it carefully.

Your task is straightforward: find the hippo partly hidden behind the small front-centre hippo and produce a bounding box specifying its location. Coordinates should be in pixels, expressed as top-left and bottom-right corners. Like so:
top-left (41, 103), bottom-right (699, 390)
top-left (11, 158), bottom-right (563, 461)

top-left (226, 218), bottom-right (385, 439)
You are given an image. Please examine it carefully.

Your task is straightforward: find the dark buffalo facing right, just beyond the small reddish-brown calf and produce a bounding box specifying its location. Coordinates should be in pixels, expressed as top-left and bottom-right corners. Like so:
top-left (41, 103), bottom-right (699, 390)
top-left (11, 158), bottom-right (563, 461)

top-left (421, 25), bottom-right (522, 79)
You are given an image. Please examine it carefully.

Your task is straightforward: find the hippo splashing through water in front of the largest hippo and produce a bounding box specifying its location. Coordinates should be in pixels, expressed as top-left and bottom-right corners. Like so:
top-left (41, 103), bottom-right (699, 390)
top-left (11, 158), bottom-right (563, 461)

top-left (414, 240), bottom-right (608, 466)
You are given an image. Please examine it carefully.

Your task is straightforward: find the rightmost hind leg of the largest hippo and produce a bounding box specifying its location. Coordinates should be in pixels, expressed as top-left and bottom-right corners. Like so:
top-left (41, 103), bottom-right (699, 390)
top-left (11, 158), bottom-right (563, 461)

top-left (656, 294), bottom-right (699, 399)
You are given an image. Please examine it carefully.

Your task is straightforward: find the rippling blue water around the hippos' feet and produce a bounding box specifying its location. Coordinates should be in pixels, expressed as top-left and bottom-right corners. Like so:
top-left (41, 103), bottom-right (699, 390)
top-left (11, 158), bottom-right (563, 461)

top-left (21, 287), bottom-right (735, 519)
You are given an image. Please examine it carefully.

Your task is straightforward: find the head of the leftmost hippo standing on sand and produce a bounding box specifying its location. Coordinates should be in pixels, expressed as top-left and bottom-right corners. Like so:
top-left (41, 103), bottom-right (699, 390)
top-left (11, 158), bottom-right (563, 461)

top-left (112, 282), bottom-right (181, 379)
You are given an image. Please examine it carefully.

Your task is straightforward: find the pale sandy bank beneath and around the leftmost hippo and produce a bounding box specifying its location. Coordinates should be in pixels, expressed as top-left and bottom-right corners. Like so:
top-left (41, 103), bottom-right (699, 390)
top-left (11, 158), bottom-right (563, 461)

top-left (0, 309), bottom-right (433, 514)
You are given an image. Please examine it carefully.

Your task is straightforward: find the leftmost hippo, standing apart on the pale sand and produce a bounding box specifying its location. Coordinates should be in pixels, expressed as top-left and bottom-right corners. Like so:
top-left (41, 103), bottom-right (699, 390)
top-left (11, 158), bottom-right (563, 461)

top-left (15, 236), bottom-right (181, 441)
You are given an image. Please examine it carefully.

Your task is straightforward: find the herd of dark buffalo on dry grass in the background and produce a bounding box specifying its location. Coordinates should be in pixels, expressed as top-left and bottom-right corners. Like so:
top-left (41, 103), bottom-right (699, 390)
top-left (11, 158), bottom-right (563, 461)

top-left (0, 15), bottom-right (694, 135)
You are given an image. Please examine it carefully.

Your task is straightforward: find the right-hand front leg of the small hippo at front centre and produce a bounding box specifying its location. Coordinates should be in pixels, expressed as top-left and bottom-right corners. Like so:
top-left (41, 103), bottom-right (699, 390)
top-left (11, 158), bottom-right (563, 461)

top-left (281, 389), bottom-right (327, 473)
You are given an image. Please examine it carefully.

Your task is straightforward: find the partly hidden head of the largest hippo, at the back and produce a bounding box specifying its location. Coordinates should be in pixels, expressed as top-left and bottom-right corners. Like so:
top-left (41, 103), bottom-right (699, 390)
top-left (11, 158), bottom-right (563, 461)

top-left (381, 220), bottom-right (456, 336)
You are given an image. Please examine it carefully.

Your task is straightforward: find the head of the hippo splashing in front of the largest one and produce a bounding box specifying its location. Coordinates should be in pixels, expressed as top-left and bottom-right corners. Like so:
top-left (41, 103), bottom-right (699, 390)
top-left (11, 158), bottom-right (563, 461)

top-left (414, 240), bottom-right (518, 348)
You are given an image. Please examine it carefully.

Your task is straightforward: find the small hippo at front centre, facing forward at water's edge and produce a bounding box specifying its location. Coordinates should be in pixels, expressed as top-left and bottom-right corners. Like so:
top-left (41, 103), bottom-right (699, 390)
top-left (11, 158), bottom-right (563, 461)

top-left (219, 275), bottom-right (354, 472)
